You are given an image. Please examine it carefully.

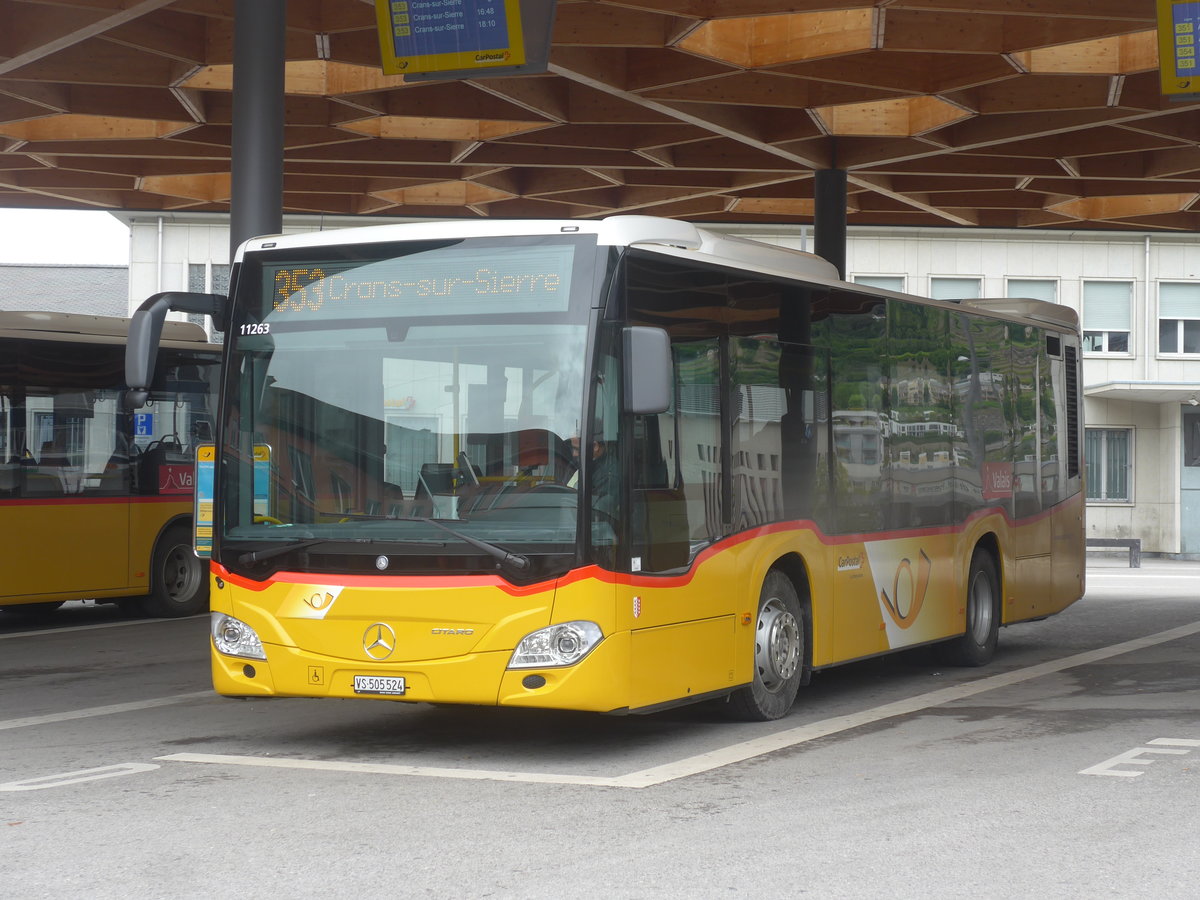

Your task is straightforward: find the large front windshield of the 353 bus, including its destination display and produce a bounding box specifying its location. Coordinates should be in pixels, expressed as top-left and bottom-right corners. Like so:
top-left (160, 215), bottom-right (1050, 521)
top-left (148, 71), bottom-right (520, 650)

top-left (221, 236), bottom-right (595, 575)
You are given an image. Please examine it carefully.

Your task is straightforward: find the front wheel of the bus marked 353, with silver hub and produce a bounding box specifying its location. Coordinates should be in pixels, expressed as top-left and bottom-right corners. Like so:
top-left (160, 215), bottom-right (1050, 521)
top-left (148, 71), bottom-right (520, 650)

top-left (728, 569), bottom-right (804, 721)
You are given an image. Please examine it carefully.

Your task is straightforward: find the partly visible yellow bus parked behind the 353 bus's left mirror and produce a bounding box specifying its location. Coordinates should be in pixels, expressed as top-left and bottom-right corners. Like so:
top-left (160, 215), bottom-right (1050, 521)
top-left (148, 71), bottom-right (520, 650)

top-left (0, 312), bottom-right (220, 617)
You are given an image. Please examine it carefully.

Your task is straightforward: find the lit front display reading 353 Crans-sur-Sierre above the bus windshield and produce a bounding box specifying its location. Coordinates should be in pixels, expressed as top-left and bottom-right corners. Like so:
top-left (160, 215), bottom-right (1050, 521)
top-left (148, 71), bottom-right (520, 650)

top-left (261, 244), bottom-right (575, 321)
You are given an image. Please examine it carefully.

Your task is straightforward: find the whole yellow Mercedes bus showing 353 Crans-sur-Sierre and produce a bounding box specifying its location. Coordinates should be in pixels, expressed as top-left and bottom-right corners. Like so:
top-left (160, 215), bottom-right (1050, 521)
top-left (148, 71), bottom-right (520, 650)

top-left (130, 222), bottom-right (1084, 720)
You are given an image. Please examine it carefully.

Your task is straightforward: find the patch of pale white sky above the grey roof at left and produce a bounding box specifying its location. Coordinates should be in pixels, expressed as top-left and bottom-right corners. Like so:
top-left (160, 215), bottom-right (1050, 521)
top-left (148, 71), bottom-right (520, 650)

top-left (0, 209), bottom-right (130, 265)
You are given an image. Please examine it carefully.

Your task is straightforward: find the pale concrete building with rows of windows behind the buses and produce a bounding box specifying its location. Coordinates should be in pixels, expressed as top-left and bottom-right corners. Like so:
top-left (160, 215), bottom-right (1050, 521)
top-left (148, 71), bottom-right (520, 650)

top-left (116, 212), bottom-right (1200, 558)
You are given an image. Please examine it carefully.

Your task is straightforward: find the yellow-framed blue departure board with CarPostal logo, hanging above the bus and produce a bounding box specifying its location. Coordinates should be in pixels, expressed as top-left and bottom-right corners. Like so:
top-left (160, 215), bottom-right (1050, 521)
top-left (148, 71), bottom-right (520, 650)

top-left (376, 0), bottom-right (526, 74)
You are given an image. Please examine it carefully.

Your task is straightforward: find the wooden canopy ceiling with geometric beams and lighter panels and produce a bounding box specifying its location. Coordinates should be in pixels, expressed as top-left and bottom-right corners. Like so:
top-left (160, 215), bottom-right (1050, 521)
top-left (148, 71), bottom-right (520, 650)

top-left (0, 0), bottom-right (1200, 230)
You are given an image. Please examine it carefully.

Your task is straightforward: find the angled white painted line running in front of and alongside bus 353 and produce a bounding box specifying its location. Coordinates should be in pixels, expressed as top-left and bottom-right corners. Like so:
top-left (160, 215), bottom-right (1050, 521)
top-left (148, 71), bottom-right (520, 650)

top-left (156, 622), bottom-right (1200, 788)
